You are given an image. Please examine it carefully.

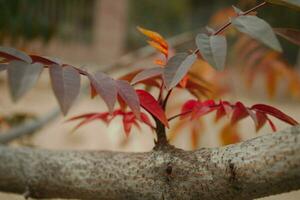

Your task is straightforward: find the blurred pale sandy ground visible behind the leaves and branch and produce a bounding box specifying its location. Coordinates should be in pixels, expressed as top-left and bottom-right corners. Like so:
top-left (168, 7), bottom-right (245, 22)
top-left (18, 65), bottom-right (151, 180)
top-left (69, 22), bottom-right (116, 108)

top-left (0, 69), bottom-right (300, 200)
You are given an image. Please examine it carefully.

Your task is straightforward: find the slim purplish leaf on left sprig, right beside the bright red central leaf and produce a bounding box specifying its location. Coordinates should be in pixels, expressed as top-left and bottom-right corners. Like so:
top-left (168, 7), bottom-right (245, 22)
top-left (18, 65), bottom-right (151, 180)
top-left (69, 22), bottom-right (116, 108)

top-left (116, 80), bottom-right (140, 118)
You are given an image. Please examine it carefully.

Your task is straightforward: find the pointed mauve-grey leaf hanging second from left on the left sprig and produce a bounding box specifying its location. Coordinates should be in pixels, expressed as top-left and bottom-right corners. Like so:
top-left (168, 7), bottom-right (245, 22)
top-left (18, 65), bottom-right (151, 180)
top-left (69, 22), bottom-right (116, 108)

top-left (49, 65), bottom-right (80, 115)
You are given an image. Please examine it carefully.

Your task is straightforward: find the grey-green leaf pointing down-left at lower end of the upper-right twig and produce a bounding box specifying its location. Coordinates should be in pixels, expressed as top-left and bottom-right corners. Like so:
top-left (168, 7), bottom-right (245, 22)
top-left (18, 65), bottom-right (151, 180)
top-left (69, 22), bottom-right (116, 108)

top-left (163, 53), bottom-right (196, 90)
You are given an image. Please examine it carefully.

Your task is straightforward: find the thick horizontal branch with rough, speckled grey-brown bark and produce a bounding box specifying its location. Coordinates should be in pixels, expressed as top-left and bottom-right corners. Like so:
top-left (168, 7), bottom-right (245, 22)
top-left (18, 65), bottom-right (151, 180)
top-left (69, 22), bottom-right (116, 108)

top-left (0, 126), bottom-right (300, 200)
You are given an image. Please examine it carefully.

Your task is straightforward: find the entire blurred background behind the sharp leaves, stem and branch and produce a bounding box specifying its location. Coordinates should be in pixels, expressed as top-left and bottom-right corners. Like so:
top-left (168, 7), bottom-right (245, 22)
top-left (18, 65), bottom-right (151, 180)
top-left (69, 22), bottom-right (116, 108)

top-left (0, 0), bottom-right (300, 200)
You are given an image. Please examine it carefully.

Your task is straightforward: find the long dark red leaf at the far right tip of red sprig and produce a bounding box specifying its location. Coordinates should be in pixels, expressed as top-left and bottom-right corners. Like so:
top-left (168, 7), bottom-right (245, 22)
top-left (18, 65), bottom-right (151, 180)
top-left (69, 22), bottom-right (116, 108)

top-left (251, 104), bottom-right (299, 125)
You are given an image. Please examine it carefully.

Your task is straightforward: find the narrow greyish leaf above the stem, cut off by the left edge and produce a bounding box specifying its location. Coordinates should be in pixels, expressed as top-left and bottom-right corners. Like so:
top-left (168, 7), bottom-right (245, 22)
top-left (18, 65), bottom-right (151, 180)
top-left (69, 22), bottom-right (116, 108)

top-left (0, 47), bottom-right (32, 63)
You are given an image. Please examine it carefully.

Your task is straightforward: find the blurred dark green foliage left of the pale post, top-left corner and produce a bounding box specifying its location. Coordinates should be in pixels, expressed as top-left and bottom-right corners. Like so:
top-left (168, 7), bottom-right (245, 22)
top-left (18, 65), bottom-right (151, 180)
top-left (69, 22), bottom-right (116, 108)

top-left (0, 0), bottom-right (94, 42)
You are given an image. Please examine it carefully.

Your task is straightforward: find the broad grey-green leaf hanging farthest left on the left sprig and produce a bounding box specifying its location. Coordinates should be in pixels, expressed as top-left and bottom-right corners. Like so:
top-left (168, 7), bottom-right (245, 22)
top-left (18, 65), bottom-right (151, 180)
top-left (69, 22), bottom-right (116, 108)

top-left (7, 60), bottom-right (43, 101)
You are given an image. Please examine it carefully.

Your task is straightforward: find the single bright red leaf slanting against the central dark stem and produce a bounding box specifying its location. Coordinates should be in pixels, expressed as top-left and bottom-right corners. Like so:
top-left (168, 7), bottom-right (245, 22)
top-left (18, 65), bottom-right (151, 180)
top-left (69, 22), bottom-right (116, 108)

top-left (136, 90), bottom-right (169, 128)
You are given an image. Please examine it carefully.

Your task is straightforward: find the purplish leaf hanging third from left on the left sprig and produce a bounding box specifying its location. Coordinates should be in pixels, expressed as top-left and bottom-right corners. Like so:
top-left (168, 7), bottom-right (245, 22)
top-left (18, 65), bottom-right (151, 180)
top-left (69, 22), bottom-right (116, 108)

top-left (88, 71), bottom-right (118, 113)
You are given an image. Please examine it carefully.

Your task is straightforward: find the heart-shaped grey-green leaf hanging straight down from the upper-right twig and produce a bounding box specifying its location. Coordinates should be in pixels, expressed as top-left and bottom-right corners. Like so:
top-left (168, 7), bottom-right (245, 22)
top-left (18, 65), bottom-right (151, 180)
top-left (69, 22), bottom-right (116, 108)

top-left (196, 33), bottom-right (227, 70)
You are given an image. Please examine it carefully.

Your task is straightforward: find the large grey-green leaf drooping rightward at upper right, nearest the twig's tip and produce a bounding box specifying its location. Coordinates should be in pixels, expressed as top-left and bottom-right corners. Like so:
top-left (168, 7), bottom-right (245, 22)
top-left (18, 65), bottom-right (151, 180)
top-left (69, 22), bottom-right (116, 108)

top-left (232, 15), bottom-right (282, 52)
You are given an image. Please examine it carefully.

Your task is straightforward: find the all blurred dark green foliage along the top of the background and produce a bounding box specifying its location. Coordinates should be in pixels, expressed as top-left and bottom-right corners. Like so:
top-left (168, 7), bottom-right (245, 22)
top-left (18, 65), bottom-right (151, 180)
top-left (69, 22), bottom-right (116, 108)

top-left (0, 0), bottom-right (300, 60)
